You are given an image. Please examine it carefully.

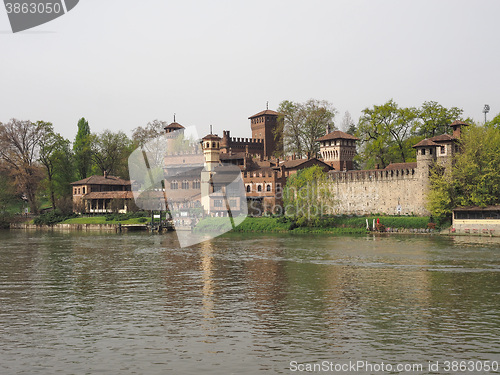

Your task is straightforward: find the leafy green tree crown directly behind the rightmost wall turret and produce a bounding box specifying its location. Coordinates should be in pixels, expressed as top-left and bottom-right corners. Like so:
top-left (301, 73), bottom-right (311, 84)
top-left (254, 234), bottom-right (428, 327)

top-left (418, 101), bottom-right (463, 138)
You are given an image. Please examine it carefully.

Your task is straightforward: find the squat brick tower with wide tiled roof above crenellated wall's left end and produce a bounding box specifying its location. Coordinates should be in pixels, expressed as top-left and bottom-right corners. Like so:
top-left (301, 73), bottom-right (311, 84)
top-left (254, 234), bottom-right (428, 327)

top-left (317, 129), bottom-right (359, 171)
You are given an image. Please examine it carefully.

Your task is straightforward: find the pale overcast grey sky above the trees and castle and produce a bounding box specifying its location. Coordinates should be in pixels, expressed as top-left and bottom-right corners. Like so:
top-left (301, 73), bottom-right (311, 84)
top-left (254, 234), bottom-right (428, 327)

top-left (0, 0), bottom-right (500, 140)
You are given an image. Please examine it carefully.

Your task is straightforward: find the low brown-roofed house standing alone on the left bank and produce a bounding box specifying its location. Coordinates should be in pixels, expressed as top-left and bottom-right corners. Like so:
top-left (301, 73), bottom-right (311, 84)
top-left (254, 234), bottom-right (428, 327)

top-left (71, 173), bottom-right (134, 214)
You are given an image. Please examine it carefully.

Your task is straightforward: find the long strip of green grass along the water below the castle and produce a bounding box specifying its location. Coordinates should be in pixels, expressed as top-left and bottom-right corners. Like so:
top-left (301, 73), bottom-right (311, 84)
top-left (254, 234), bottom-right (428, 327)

top-left (196, 216), bottom-right (429, 234)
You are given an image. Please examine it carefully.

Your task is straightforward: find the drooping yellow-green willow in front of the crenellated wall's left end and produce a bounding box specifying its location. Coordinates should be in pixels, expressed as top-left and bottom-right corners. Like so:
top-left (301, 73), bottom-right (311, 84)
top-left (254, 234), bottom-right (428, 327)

top-left (283, 165), bottom-right (334, 220)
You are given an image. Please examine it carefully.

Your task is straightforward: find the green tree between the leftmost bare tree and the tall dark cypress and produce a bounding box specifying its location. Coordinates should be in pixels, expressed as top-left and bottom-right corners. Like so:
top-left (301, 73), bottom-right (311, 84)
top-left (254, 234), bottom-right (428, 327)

top-left (39, 121), bottom-right (74, 210)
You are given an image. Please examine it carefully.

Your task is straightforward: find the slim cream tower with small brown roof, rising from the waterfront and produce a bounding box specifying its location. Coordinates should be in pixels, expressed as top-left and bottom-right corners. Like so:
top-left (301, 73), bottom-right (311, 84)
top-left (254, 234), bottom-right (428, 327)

top-left (201, 134), bottom-right (221, 213)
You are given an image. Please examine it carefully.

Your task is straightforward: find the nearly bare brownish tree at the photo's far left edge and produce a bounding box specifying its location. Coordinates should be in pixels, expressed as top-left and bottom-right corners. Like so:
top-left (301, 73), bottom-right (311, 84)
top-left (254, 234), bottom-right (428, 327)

top-left (0, 119), bottom-right (45, 214)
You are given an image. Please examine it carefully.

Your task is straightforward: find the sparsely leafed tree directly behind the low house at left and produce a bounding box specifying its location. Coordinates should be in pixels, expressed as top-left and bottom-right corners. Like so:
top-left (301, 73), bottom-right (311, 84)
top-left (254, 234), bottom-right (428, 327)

top-left (91, 130), bottom-right (134, 178)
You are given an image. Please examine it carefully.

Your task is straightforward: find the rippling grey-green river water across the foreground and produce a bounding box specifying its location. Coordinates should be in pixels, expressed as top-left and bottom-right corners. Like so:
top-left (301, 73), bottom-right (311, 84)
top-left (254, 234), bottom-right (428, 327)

top-left (0, 231), bottom-right (500, 375)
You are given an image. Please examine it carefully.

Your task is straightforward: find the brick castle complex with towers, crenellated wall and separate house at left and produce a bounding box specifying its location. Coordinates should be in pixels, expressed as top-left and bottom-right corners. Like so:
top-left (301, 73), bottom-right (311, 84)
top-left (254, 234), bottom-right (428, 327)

top-left (73, 109), bottom-right (467, 216)
